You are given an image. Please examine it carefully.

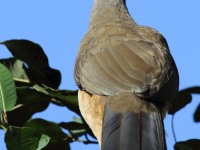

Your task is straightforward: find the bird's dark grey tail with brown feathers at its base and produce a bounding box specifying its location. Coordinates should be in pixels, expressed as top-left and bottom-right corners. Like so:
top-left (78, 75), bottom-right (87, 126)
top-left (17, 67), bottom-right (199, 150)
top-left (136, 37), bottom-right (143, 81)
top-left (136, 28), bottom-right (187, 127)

top-left (101, 93), bottom-right (166, 150)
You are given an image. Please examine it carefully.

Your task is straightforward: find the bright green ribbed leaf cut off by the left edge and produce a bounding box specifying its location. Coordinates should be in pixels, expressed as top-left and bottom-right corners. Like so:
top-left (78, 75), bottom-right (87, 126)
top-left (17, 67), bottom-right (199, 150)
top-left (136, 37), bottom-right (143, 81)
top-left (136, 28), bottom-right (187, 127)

top-left (0, 64), bottom-right (17, 112)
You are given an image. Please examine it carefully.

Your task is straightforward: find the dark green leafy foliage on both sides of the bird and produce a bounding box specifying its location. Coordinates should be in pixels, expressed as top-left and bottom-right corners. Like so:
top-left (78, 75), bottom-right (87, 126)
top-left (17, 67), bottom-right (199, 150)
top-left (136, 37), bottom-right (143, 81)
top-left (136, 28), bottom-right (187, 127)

top-left (0, 40), bottom-right (200, 150)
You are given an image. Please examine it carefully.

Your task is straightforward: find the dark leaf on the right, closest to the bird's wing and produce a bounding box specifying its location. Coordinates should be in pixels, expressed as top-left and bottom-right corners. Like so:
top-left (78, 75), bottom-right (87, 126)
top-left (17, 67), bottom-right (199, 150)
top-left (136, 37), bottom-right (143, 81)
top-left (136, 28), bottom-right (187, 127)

top-left (168, 87), bottom-right (200, 115)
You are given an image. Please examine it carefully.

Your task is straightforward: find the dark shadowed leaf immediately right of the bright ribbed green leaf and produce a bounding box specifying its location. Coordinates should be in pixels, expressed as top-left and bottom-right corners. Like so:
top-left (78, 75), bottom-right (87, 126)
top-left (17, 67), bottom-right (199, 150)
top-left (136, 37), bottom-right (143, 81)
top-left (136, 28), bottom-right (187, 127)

top-left (7, 87), bottom-right (51, 126)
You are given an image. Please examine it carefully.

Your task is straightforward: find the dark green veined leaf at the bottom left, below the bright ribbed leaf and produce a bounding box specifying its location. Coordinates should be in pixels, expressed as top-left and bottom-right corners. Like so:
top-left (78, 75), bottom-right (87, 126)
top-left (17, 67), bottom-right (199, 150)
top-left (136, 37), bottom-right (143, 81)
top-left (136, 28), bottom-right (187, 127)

top-left (5, 126), bottom-right (40, 150)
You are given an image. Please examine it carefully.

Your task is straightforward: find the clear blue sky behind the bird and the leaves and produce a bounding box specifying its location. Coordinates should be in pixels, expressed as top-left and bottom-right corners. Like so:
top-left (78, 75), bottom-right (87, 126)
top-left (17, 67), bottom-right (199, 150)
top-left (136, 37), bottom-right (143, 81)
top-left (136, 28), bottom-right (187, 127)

top-left (0, 0), bottom-right (200, 150)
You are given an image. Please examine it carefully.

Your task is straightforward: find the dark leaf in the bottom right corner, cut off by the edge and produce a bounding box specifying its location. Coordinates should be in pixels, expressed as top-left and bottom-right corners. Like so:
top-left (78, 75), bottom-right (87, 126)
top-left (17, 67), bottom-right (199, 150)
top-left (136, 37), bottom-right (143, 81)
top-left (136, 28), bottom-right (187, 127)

top-left (174, 139), bottom-right (200, 150)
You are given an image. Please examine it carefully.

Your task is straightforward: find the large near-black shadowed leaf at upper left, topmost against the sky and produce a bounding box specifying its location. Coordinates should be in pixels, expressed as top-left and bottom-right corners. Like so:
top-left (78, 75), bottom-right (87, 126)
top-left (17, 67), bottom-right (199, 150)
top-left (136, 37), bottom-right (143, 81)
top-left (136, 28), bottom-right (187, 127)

top-left (0, 40), bottom-right (61, 88)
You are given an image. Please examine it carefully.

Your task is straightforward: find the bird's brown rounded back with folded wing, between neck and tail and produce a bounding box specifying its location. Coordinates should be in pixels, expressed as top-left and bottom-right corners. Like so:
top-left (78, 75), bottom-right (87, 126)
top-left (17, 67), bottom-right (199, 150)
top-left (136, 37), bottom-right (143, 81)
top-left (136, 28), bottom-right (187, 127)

top-left (75, 25), bottom-right (176, 99)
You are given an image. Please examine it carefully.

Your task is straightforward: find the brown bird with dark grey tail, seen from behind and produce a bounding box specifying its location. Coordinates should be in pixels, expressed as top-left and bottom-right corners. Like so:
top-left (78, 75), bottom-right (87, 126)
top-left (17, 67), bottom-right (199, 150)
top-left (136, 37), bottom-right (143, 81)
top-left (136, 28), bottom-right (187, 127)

top-left (74, 0), bottom-right (179, 150)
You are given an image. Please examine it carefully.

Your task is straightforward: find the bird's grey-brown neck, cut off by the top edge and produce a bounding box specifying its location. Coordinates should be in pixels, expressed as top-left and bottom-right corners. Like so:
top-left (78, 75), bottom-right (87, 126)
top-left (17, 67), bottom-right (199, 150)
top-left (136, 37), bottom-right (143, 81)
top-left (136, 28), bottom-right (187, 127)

top-left (89, 0), bottom-right (135, 29)
